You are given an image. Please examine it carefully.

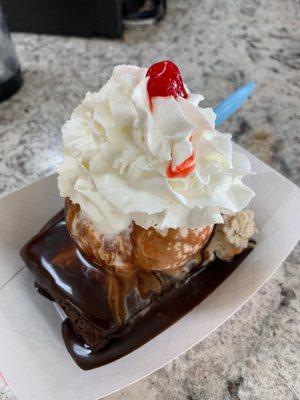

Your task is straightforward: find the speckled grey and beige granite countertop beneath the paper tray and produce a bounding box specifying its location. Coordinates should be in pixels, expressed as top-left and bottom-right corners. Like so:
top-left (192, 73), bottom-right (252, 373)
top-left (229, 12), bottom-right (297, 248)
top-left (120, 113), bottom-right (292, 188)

top-left (0, 0), bottom-right (300, 400)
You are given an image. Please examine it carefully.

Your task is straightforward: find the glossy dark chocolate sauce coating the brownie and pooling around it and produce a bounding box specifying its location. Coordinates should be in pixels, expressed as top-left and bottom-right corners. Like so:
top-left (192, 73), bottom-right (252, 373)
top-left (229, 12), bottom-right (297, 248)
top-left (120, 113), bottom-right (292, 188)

top-left (21, 212), bottom-right (253, 369)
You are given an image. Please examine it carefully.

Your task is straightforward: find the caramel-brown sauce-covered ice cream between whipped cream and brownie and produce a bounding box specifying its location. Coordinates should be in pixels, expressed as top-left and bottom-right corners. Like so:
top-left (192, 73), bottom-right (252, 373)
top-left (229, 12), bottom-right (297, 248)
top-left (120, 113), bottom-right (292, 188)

top-left (65, 199), bottom-right (213, 277)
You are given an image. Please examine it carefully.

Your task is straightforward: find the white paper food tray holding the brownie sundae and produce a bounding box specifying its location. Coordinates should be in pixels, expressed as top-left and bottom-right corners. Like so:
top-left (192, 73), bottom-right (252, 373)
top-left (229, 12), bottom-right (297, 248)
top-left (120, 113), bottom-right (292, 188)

top-left (0, 148), bottom-right (300, 400)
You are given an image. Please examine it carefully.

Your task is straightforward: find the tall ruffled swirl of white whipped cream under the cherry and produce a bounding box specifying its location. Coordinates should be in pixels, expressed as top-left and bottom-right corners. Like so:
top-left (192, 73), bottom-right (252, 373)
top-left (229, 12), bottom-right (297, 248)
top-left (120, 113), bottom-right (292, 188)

top-left (58, 65), bottom-right (254, 235)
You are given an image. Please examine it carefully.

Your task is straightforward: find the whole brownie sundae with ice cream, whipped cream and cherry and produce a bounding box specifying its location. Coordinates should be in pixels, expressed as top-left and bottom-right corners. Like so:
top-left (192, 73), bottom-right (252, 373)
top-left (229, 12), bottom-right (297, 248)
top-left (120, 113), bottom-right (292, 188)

top-left (21, 61), bottom-right (256, 369)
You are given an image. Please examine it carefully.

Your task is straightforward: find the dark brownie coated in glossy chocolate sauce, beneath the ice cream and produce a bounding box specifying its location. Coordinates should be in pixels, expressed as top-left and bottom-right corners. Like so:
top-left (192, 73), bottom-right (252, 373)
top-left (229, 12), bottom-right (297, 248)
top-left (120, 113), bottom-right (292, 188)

top-left (21, 212), bottom-right (185, 351)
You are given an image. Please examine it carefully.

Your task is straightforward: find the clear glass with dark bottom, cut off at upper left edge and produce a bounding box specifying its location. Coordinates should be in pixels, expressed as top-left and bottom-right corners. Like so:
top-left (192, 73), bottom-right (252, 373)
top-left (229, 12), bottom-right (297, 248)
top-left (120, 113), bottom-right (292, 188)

top-left (0, 5), bottom-right (22, 101)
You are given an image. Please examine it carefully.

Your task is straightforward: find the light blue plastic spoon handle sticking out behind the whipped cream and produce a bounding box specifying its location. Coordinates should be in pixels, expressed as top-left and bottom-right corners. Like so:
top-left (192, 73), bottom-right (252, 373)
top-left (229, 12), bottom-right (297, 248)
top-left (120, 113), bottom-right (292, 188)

top-left (214, 82), bottom-right (255, 126)
